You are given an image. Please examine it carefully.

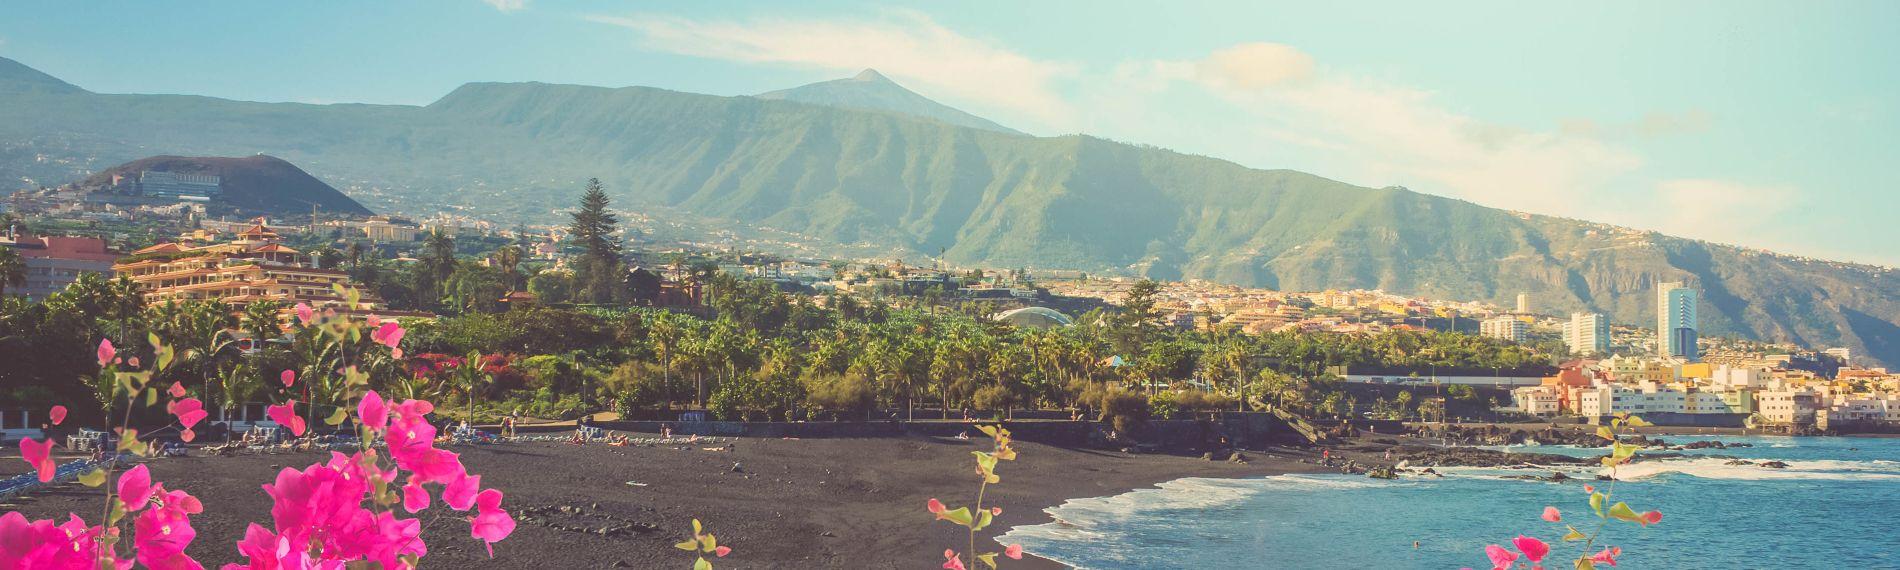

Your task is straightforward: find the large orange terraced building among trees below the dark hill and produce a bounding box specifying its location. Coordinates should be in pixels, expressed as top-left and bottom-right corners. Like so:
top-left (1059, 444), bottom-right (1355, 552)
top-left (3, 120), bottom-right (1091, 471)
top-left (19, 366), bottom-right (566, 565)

top-left (112, 226), bottom-right (424, 326)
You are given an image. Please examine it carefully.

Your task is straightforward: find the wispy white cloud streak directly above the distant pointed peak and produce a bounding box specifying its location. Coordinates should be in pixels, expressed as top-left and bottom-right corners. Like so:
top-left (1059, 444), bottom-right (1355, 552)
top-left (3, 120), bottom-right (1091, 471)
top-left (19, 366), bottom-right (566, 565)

top-left (587, 10), bottom-right (1074, 124)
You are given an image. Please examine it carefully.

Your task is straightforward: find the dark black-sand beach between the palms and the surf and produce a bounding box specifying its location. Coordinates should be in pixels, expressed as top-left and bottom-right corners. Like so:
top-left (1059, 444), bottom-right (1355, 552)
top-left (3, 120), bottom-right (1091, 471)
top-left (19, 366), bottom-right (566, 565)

top-left (0, 437), bottom-right (1321, 568)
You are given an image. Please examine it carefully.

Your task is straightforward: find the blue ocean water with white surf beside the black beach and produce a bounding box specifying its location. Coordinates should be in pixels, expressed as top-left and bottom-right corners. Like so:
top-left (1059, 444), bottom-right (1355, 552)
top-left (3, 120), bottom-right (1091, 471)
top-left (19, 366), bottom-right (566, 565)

top-left (1001, 437), bottom-right (1900, 570)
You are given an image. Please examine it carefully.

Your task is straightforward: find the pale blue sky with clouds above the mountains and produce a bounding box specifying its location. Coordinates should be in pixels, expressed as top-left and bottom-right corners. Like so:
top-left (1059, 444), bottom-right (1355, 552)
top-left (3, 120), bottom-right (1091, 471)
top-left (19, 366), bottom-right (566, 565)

top-left (0, 0), bottom-right (1900, 266)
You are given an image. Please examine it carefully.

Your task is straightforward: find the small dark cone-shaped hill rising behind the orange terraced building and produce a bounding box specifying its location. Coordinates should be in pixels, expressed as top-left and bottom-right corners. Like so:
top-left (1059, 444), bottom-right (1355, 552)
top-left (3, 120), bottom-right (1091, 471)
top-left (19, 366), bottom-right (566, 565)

top-left (78, 154), bottom-right (371, 215)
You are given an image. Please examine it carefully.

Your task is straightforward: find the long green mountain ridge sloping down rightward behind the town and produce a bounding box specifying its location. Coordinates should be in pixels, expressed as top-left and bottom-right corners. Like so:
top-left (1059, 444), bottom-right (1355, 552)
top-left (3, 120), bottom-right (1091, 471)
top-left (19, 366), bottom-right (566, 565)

top-left (0, 56), bottom-right (1900, 365)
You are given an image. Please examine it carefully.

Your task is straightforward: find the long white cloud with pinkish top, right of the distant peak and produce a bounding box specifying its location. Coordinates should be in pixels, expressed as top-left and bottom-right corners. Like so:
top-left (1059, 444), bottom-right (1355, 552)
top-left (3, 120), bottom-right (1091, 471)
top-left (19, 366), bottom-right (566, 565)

top-left (1146, 44), bottom-right (1644, 215)
